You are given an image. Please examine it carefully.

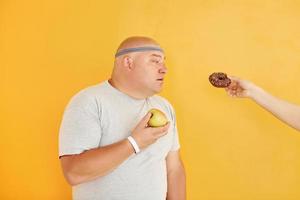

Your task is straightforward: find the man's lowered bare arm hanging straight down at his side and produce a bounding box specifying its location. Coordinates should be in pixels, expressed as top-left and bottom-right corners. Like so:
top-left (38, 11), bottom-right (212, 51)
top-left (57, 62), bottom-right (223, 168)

top-left (166, 151), bottom-right (186, 200)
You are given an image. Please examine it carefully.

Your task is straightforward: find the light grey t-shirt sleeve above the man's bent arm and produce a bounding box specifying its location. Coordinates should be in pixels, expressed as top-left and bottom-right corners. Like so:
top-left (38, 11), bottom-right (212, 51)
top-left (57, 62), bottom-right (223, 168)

top-left (59, 92), bottom-right (102, 157)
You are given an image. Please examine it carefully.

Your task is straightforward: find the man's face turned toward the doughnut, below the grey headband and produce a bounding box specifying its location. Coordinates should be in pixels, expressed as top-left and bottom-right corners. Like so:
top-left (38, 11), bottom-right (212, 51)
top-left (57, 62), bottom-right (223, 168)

top-left (133, 51), bottom-right (167, 94)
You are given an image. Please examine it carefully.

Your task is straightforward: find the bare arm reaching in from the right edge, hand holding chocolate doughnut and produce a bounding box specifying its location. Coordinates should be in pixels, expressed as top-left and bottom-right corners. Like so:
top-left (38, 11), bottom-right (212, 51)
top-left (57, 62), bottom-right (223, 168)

top-left (226, 77), bottom-right (300, 131)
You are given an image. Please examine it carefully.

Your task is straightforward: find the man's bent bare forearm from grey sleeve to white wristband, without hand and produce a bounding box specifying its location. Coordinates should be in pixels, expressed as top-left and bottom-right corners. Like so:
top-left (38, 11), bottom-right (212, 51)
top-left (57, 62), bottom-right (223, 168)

top-left (60, 139), bottom-right (134, 185)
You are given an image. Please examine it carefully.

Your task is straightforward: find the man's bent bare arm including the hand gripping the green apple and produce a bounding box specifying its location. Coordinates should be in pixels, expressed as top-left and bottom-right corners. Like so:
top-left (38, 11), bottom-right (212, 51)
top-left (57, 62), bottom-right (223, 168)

top-left (60, 113), bottom-right (169, 185)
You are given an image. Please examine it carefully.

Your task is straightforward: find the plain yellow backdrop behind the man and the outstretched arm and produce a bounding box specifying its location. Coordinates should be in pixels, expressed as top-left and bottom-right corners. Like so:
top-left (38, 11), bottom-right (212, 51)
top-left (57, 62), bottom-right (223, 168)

top-left (0, 0), bottom-right (300, 200)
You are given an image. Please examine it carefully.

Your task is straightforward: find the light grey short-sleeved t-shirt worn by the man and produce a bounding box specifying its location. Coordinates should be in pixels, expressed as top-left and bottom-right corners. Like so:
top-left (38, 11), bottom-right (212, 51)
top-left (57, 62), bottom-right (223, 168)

top-left (59, 81), bottom-right (180, 200)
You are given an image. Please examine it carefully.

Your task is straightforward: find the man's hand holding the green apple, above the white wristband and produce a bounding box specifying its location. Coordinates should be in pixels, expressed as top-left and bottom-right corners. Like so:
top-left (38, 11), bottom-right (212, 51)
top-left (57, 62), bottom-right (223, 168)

top-left (131, 113), bottom-right (170, 149)
